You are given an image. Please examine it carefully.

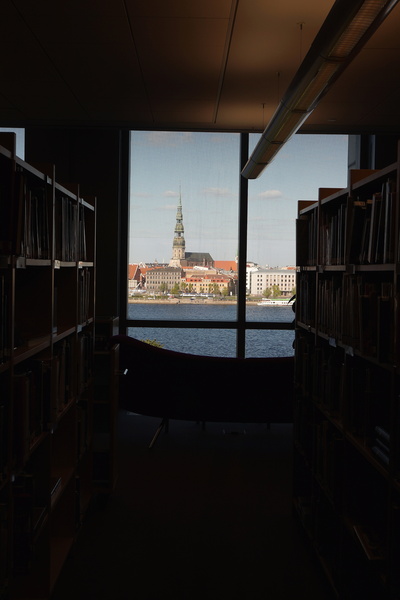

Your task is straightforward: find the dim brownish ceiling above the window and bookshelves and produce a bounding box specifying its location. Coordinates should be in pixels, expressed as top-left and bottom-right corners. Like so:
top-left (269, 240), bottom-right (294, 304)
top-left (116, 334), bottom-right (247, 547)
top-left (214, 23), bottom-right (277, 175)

top-left (0, 0), bottom-right (400, 133)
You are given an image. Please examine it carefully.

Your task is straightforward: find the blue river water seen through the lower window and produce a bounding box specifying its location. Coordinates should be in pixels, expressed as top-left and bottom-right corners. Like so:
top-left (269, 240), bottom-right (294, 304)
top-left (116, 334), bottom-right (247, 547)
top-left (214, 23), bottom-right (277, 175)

top-left (128, 302), bottom-right (294, 358)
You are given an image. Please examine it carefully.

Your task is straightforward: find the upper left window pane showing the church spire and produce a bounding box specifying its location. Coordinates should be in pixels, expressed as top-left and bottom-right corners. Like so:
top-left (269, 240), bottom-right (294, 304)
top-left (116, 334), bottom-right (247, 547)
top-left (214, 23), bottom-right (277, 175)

top-left (128, 132), bottom-right (240, 320)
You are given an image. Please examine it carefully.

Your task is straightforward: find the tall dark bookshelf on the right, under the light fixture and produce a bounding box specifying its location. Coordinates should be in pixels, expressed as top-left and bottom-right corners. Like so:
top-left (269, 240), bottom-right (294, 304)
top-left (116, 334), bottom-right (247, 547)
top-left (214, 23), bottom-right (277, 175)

top-left (293, 143), bottom-right (400, 599)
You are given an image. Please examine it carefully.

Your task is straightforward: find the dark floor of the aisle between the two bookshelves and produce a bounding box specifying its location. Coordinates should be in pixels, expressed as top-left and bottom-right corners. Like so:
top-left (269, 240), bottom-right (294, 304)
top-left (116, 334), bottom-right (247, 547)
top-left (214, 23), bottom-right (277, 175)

top-left (53, 411), bottom-right (331, 600)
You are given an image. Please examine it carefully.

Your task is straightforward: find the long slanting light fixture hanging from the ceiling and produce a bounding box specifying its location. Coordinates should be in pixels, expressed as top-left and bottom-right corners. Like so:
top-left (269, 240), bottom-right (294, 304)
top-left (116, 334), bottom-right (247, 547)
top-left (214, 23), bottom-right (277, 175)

top-left (242, 0), bottom-right (398, 179)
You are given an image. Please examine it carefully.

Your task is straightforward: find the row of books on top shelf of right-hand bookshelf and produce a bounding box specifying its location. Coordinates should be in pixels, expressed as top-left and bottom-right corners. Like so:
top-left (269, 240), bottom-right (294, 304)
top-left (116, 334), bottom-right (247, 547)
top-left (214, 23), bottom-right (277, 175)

top-left (297, 179), bottom-right (399, 266)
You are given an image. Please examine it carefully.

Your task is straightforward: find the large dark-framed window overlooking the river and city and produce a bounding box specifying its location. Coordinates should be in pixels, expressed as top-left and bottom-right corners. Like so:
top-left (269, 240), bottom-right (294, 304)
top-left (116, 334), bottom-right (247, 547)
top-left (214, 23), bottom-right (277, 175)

top-left (127, 131), bottom-right (347, 357)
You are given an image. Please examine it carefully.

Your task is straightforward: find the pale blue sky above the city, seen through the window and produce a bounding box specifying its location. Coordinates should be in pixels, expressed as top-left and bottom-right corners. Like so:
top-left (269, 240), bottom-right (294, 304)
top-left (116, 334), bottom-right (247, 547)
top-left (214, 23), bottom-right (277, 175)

top-left (129, 131), bottom-right (347, 267)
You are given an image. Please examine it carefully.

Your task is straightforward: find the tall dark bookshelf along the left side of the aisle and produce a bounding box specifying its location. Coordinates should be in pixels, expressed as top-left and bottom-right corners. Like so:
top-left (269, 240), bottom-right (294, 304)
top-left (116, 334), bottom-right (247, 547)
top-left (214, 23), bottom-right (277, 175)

top-left (0, 134), bottom-right (96, 599)
